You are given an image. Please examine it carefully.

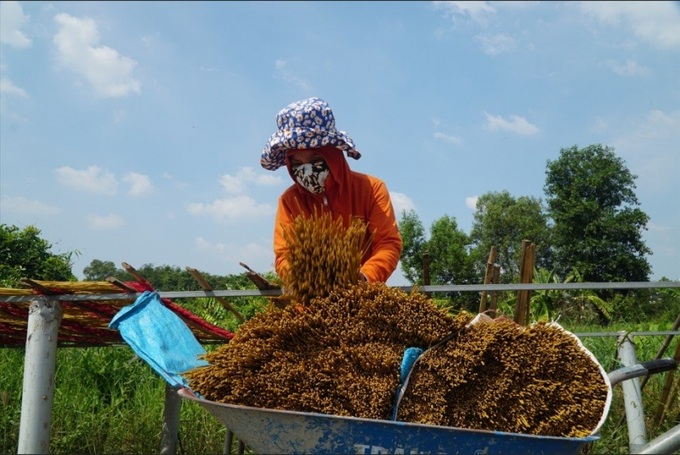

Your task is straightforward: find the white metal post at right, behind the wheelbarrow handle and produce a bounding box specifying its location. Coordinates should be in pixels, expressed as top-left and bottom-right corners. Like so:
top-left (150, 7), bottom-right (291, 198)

top-left (618, 332), bottom-right (647, 453)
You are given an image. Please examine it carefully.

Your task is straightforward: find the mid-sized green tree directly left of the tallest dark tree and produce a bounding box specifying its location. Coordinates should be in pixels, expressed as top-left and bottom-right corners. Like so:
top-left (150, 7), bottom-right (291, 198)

top-left (470, 191), bottom-right (552, 283)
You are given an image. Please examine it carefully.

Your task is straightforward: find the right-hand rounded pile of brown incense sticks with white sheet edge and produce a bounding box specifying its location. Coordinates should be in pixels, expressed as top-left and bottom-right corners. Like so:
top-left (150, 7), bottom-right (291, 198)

top-left (399, 320), bottom-right (609, 437)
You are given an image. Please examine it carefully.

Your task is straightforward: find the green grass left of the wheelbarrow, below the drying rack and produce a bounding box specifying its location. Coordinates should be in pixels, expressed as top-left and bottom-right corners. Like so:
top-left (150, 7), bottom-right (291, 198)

top-left (0, 347), bottom-right (226, 454)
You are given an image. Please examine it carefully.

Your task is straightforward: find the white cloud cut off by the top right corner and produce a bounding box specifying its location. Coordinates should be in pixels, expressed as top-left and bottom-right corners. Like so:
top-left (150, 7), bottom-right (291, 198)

top-left (580, 1), bottom-right (680, 49)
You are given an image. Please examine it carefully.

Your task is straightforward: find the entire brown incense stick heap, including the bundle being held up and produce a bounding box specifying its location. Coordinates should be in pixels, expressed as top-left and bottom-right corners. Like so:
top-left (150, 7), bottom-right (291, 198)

top-left (186, 215), bottom-right (610, 437)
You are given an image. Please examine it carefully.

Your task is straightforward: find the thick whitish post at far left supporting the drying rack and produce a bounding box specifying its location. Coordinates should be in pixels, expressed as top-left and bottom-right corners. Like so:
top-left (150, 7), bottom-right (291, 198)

top-left (17, 296), bottom-right (63, 454)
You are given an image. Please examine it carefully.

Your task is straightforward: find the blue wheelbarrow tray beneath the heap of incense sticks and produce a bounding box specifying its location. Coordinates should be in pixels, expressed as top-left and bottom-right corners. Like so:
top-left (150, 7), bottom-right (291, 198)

top-left (178, 388), bottom-right (599, 455)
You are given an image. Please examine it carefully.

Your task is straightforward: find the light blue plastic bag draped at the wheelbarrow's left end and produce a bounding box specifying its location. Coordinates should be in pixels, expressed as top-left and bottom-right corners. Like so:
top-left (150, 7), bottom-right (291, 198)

top-left (109, 291), bottom-right (208, 387)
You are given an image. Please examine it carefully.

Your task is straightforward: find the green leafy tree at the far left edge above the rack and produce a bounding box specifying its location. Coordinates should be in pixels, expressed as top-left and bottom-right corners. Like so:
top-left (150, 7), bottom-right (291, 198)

top-left (0, 224), bottom-right (78, 287)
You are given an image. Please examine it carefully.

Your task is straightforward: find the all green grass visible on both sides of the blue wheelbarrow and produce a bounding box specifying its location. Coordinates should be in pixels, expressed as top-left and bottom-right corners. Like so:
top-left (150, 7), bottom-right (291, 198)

top-left (0, 320), bottom-right (680, 454)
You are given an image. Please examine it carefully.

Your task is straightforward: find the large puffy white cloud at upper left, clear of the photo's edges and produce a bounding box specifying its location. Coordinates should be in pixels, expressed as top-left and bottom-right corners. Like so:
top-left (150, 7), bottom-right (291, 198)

top-left (54, 13), bottom-right (141, 98)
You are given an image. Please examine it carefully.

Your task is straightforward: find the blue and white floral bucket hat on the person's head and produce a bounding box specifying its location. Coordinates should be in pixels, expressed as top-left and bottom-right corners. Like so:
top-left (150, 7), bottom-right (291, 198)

top-left (260, 98), bottom-right (361, 171)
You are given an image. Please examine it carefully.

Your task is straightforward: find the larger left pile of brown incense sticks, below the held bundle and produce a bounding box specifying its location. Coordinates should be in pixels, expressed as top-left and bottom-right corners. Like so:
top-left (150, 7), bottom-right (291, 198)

top-left (186, 284), bottom-right (471, 419)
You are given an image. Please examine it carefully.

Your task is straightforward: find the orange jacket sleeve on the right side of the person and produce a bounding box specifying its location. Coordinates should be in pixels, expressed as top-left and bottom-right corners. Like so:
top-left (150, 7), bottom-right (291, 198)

top-left (361, 178), bottom-right (402, 283)
